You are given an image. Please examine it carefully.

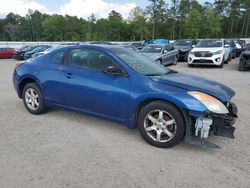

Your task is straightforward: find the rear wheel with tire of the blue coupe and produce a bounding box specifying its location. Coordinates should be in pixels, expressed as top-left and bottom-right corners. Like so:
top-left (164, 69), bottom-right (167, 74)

top-left (22, 83), bottom-right (45, 115)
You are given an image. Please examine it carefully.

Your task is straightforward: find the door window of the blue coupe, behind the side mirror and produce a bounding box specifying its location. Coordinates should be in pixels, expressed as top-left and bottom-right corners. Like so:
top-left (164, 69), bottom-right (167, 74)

top-left (69, 49), bottom-right (116, 71)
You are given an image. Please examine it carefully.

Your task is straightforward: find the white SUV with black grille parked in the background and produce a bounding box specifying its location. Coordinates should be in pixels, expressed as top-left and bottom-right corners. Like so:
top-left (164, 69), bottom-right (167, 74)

top-left (188, 39), bottom-right (230, 68)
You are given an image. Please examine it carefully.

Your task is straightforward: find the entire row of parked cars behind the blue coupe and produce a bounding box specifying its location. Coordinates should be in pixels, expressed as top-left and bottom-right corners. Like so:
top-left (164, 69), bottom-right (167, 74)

top-left (0, 39), bottom-right (249, 70)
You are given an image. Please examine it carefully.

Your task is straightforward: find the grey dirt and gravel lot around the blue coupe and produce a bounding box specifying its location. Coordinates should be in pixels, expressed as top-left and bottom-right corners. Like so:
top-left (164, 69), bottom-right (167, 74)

top-left (0, 59), bottom-right (250, 188)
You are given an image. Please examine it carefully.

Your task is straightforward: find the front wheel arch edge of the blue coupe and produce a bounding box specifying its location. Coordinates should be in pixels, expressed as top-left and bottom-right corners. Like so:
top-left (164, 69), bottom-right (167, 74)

top-left (134, 98), bottom-right (185, 127)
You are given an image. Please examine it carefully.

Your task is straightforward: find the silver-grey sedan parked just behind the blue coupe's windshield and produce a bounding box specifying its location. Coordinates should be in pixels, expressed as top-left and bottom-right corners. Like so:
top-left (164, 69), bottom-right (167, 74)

top-left (140, 44), bottom-right (179, 66)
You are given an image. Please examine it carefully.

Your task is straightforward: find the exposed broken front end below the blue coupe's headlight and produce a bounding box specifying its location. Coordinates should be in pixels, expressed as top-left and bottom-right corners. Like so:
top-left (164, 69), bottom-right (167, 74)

top-left (185, 102), bottom-right (238, 148)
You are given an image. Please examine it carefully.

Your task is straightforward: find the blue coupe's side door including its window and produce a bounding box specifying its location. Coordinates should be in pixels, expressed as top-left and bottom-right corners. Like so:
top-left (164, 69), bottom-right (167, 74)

top-left (61, 48), bottom-right (131, 120)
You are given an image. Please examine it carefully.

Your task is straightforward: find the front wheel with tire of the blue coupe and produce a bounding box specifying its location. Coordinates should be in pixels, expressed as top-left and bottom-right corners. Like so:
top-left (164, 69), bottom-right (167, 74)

top-left (138, 101), bottom-right (185, 148)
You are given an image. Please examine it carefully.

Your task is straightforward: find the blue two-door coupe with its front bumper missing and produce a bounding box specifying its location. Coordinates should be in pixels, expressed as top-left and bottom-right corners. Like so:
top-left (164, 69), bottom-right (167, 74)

top-left (13, 45), bottom-right (237, 148)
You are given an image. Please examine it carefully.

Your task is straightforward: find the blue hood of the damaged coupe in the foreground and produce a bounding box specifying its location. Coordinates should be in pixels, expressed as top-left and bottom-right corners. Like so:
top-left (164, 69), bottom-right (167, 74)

top-left (150, 73), bottom-right (235, 102)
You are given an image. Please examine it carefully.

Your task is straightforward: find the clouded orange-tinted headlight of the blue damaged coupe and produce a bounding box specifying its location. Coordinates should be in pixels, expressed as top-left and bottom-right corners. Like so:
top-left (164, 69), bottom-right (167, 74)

top-left (188, 91), bottom-right (229, 114)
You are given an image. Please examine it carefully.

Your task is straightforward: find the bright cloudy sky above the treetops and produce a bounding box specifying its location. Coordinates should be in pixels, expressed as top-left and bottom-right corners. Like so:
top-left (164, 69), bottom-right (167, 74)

top-left (0, 0), bottom-right (213, 18)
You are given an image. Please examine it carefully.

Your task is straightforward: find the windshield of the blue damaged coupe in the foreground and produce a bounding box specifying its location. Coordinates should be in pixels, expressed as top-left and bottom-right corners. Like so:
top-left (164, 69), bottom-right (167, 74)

top-left (111, 48), bottom-right (169, 76)
